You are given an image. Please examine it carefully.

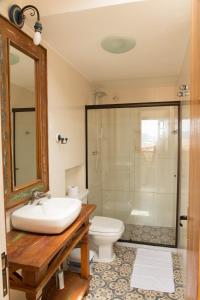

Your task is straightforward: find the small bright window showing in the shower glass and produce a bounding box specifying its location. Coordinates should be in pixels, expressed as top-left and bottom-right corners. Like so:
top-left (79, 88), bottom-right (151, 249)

top-left (141, 120), bottom-right (159, 152)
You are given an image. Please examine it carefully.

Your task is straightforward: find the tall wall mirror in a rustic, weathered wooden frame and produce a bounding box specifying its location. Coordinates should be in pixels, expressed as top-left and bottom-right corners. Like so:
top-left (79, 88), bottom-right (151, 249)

top-left (0, 16), bottom-right (48, 209)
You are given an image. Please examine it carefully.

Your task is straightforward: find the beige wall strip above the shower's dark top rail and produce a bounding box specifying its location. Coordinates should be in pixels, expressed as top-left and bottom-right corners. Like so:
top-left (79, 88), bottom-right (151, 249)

top-left (93, 77), bottom-right (177, 104)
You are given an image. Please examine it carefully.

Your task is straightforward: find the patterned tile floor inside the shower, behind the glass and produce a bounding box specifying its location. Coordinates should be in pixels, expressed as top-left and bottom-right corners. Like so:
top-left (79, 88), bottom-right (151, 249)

top-left (121, 224), bottom-right (176, 246)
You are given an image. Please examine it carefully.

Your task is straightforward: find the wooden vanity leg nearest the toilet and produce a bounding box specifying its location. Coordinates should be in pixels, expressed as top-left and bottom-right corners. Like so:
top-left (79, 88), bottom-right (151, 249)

top-left (81, 233), bottom-right (90, 279)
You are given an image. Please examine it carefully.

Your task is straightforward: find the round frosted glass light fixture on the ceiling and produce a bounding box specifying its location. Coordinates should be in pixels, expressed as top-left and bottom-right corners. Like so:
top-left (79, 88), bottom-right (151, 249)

top-left (101, 36), bottom-right (136, 54)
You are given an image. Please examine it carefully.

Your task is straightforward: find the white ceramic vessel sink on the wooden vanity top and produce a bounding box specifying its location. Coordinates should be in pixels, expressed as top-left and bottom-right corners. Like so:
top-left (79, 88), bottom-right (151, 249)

top-left (11, 198), bottom-right (82, 234)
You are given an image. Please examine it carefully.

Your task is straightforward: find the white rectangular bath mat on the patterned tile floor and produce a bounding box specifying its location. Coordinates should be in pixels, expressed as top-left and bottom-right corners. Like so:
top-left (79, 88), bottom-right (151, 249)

top-left (131, 248), bottom-right (175, 293)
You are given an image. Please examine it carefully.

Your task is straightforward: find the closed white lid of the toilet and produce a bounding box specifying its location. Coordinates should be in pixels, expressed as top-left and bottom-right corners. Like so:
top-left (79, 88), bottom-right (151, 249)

top-left (90, 216), bottom-right (123, 233)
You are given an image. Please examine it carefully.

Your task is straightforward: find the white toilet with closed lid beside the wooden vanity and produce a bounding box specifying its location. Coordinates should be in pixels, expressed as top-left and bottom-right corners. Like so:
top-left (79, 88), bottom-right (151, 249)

top-left (89, 216), bottom-right (125, 262)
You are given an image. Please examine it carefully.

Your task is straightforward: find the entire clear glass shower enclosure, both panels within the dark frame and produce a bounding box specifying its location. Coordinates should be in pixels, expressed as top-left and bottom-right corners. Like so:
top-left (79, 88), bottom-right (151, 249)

top-left (87, 105), bottom-right (179, 246)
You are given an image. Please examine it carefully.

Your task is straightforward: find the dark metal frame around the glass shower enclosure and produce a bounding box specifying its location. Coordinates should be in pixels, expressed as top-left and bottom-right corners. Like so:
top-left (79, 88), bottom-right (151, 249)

top-left (85, 101), bottom-right (181, 248)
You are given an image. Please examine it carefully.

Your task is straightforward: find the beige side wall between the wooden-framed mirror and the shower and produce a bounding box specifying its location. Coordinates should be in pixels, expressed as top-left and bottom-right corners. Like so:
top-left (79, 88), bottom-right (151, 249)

top-left (48, 50), bottom-right (90, 196)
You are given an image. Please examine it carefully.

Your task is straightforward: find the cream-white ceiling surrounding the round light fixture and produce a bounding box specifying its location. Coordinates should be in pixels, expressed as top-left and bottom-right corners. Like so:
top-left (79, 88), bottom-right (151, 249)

top-left (23, 0), bottom-right (191, 82)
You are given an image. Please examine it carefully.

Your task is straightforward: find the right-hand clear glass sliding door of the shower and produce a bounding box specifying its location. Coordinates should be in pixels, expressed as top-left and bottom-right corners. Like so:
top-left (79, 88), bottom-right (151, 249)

top-left (123, 106), bottom-right (178, 246)
